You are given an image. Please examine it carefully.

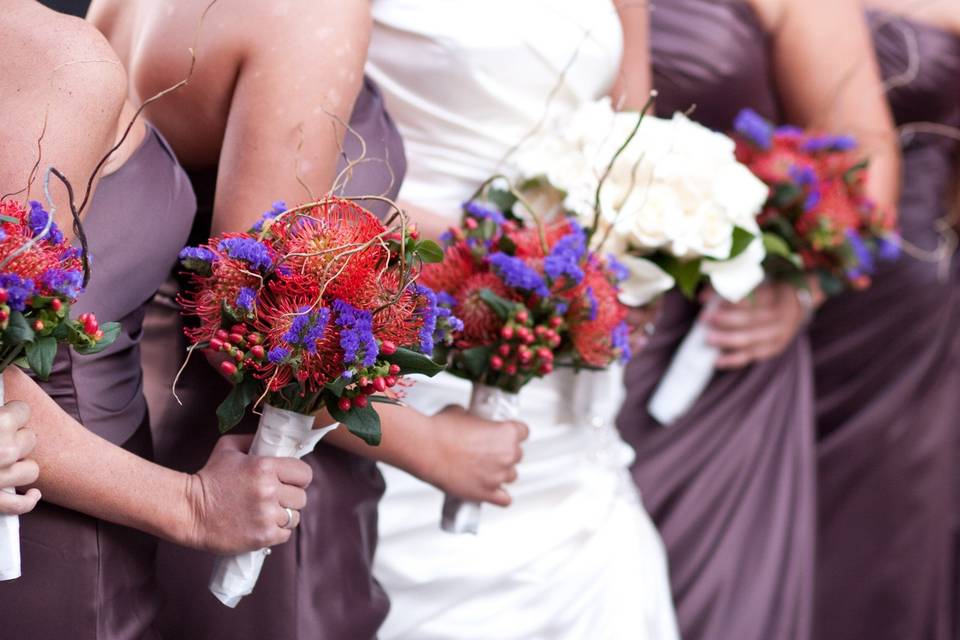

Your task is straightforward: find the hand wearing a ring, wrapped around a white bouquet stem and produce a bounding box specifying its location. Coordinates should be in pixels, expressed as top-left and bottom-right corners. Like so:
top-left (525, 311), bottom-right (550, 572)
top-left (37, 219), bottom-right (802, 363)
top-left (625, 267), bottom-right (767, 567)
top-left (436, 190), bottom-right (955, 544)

top-left (182, 436), bottom-right (313, 554)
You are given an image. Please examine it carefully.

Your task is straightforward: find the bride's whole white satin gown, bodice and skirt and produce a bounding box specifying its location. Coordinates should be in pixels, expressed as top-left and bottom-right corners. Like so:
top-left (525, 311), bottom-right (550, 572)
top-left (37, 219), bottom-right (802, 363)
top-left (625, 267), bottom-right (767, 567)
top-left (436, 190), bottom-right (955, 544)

top-left (367, 0), bottom-right (678, 640)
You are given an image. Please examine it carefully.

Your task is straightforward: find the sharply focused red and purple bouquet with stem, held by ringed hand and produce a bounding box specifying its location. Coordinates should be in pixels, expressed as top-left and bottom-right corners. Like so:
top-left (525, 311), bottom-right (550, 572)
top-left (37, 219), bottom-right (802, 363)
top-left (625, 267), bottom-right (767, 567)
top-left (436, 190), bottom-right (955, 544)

top-left (180, 196), bottom-right (459, 607)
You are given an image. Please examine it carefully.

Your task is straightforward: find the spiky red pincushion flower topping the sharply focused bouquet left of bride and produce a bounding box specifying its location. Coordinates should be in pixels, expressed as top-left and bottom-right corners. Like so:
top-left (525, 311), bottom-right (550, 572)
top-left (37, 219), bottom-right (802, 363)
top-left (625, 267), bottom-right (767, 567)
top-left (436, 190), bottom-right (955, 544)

top-left (279, 199), bottom-right (388, 303)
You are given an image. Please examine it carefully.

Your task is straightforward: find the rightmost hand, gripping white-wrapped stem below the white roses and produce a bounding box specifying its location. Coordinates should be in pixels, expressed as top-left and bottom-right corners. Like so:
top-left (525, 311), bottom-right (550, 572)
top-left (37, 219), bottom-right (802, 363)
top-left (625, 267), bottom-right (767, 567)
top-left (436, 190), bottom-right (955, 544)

top-left (703, 282), bottom-right (813, 369)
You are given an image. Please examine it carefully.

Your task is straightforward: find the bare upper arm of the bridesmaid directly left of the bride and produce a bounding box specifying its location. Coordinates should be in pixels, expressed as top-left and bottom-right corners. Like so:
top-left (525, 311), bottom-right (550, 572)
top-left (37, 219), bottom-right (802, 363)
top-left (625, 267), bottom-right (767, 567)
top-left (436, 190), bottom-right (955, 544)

top-left (213, 0), bottom-right (370, 233)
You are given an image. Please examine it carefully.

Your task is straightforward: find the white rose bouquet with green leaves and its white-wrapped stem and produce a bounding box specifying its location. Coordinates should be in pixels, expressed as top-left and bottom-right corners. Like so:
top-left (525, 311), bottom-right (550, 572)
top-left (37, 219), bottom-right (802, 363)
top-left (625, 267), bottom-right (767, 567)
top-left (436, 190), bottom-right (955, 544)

top-left (511, 99), bottom-right (769, 424)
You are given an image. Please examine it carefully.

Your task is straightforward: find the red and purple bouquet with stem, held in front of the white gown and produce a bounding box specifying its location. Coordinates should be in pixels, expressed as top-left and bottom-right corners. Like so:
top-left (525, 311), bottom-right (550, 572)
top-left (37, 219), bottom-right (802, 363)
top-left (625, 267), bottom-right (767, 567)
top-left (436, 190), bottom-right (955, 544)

top-left (420, 184), bottom-right (630, 533)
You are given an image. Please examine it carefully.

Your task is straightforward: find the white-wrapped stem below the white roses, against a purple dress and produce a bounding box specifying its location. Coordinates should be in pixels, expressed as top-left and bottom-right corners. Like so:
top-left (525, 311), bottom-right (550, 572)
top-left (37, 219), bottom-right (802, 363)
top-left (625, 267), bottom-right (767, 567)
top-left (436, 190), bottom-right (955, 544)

top-left (647, 305), bottom-right (719, 427)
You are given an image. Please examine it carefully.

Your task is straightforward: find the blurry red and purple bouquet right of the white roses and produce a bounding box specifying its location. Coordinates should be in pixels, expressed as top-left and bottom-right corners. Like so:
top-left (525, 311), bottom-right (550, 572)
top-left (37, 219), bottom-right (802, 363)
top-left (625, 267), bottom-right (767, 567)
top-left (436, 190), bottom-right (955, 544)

top-left (734, 109), bottom-right (900, 295)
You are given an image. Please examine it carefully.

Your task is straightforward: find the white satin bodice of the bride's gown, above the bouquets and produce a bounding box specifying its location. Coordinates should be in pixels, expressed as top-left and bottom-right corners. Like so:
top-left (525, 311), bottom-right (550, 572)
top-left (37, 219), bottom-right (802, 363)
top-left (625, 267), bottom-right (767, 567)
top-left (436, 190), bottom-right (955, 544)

top-left (367, 0), bottom-right (623, 216)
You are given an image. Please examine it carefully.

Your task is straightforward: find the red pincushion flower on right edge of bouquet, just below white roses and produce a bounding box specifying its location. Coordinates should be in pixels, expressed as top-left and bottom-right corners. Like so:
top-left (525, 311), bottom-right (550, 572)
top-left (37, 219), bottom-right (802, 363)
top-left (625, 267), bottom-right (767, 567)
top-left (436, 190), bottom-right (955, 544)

top-left (567, 261), bottom-right (627, 367)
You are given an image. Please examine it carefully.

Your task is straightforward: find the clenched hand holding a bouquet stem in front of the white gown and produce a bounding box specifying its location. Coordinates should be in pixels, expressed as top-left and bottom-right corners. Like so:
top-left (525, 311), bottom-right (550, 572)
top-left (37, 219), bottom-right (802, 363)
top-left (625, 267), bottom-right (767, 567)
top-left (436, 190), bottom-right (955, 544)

top-left (420, 406), bottom-right (530, 507)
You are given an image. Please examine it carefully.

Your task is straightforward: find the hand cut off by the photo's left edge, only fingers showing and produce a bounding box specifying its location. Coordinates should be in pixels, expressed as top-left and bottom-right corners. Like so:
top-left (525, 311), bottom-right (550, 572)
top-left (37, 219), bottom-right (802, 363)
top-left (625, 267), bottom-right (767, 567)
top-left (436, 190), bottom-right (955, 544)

top-left (0, 402), bottom-right (40, 516)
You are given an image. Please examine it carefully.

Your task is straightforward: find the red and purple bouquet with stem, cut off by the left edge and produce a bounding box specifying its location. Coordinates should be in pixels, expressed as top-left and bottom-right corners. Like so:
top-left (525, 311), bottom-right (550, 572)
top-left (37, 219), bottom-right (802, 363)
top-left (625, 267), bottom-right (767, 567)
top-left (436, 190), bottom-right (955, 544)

top-left (0, 200), bottom-right (120, 580)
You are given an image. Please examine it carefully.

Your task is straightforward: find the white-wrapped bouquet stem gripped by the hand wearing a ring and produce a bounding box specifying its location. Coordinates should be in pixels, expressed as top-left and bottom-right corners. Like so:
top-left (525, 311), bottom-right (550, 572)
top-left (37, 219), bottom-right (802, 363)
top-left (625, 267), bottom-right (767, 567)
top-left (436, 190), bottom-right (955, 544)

top-left (210, 405), bottom-right (338, 608)
